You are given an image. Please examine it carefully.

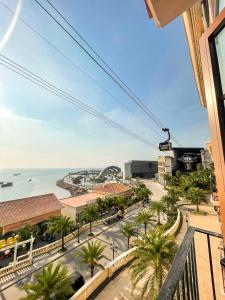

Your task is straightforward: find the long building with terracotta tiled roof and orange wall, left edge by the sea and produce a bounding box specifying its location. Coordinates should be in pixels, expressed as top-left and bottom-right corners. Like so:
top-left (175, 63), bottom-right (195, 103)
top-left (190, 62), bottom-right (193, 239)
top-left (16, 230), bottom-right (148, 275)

top-left (0, 194), bottom-right (62, 235)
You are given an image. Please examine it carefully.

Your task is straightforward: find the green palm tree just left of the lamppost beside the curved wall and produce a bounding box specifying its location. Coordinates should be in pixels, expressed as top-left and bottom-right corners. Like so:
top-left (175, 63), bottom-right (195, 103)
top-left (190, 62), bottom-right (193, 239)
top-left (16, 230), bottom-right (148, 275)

top-left (77, 241), bottom-right (106, 277)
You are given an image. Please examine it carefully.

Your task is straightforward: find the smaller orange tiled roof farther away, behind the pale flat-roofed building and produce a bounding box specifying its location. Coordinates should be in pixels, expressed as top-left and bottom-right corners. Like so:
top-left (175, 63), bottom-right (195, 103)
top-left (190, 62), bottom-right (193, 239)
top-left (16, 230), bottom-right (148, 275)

top-left (94, 183), bottom-right (130, 195)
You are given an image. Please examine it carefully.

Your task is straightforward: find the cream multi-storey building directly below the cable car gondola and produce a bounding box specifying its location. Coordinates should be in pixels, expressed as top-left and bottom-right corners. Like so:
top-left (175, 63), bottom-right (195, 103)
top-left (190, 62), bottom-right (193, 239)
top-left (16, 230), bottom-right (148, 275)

top-left (158, 156), bottom-right (174, 185)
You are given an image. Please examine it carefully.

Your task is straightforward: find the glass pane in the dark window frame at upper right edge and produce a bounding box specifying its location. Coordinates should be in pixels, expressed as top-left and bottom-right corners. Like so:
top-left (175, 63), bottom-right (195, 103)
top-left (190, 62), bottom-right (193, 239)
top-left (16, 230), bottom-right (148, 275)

top-left (215, 27), bottom-right (225, 95)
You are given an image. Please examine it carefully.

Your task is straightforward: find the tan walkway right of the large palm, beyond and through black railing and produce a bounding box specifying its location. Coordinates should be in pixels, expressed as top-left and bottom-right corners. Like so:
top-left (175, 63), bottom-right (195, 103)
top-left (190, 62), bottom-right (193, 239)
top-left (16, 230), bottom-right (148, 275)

top-left (176, 204), bottom-right (222, 300)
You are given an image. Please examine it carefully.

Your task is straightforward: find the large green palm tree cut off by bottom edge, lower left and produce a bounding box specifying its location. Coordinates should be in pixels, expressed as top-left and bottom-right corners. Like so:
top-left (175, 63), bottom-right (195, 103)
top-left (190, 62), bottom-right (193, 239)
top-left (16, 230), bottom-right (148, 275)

top-left (20, 263), bottom-right (73, 300)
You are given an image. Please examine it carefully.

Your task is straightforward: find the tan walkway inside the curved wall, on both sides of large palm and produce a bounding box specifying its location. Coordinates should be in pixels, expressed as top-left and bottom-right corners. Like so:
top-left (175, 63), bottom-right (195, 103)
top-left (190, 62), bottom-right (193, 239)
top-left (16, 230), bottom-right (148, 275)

top-left (95, 205), bottom-right (221, 300)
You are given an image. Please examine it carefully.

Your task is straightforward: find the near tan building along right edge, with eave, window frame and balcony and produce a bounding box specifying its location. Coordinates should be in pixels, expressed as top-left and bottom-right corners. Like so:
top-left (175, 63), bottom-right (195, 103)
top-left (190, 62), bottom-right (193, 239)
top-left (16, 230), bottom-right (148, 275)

top-left (145, 0), bottom-right (225, 300)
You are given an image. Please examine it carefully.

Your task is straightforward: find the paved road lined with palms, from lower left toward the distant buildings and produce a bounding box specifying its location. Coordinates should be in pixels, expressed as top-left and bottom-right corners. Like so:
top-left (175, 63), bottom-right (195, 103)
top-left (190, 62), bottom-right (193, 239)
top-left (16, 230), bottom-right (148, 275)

top-left (0, 181), bottom-right (165, 300)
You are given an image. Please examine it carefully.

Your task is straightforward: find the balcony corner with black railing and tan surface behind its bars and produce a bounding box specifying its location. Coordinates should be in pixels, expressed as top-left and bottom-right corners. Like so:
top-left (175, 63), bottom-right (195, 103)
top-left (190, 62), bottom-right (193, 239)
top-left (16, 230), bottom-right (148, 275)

top-left (157, 227), bottom-right (222, 300)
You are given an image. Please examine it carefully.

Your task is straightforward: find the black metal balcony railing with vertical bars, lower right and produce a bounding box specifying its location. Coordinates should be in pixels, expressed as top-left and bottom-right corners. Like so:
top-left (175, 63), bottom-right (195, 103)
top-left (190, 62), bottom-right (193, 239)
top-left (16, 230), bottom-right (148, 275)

top-left (157, 227), bottom-right (222, 300)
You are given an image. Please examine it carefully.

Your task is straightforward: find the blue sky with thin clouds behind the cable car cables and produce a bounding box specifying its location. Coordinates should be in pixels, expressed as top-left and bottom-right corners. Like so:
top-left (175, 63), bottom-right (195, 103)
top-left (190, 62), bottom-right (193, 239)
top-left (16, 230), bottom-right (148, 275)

top-left (0, 0), bottom-right (210, 168)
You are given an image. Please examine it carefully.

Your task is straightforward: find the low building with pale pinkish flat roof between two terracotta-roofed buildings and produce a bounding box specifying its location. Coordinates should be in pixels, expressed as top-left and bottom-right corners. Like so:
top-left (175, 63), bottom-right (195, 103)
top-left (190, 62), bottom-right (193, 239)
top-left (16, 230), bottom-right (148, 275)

top-left (60, 193), bottom-right (104, 221)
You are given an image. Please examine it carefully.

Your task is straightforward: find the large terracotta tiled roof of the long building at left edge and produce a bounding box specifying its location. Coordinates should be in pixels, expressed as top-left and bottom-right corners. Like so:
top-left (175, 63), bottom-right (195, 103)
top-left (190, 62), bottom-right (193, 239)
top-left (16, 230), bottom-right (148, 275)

top-left (0, 194), bottom-right (62, 226)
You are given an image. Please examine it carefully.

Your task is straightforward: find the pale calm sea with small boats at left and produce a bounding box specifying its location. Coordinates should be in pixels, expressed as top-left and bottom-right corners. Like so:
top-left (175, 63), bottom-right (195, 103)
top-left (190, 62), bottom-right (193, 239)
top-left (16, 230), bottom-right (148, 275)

top-left (0, 169), bottom-right (80, 201)
